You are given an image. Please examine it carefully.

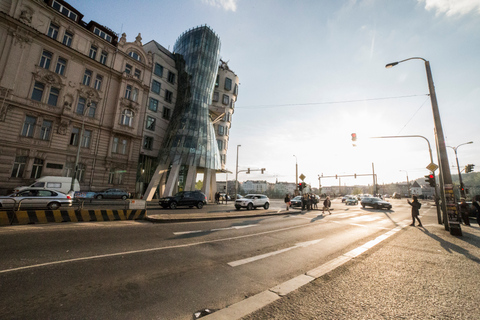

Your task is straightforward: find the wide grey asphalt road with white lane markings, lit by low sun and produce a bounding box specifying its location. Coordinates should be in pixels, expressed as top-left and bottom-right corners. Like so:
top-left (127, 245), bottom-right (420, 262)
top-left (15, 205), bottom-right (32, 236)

top-left (0, 200), bottom-right (410, 319)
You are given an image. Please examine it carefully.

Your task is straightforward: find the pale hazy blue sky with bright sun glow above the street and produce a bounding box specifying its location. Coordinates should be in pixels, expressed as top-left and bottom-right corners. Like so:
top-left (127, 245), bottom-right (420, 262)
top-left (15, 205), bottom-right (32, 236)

top-left (68, 0), bottom-right (480, 186)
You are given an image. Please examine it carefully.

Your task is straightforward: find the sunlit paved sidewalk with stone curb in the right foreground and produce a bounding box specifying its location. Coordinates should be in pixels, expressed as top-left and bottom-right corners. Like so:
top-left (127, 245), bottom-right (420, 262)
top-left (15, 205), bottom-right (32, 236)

top-left (205, 213), bottom-right (480, 320)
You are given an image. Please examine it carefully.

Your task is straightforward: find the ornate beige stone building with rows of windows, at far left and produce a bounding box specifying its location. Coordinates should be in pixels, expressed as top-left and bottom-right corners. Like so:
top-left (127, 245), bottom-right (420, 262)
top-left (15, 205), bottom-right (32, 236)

top-left (0, 0), bottom-right (152, 194)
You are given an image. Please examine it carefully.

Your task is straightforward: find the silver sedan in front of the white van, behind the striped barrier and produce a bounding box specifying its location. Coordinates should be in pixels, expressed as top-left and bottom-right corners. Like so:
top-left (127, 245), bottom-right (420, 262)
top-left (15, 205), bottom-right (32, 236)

top-left (0, 188), bottom-right (73, 210)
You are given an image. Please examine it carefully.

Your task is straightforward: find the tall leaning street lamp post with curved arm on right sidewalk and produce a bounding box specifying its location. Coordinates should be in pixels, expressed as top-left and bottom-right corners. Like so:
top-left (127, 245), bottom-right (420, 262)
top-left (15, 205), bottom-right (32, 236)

top-left (385, 57), bottom-right (462, 236)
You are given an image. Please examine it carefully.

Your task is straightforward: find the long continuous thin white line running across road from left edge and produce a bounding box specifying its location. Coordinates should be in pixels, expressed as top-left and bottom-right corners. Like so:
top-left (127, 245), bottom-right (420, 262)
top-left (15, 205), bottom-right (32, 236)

top-left (0, 225), bottom-right (314, 274)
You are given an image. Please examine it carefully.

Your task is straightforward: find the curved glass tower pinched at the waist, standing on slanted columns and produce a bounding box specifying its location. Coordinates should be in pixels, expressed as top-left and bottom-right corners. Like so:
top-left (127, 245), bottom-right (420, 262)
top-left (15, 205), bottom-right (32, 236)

top-left (146, 26), bottom-right (221, 199)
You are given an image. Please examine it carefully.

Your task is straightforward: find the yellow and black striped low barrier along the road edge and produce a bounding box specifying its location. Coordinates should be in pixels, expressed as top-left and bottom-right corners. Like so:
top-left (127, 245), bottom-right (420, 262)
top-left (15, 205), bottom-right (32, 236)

top-left (0, 209), bottom-right (146, 226)
